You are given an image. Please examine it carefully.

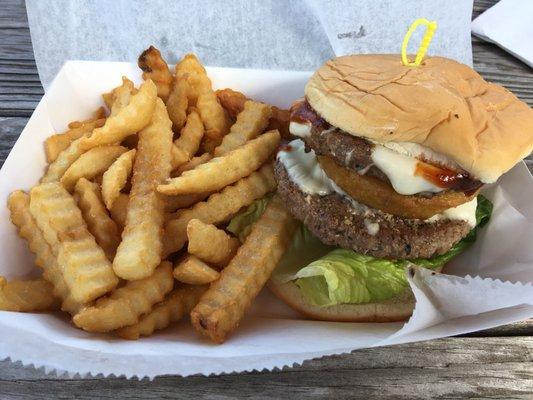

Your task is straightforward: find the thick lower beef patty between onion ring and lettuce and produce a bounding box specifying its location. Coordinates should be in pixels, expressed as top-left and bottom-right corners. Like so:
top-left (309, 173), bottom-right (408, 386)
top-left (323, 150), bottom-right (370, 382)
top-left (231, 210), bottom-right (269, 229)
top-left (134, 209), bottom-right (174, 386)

top-left (275, 161), bottom-right (471, 259)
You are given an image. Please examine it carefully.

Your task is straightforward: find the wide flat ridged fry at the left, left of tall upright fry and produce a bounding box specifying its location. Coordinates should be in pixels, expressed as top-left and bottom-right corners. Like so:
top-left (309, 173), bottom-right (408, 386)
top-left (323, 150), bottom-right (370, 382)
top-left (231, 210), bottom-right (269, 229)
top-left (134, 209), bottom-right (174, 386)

top-left (30, 182), bottom-right (118, 303)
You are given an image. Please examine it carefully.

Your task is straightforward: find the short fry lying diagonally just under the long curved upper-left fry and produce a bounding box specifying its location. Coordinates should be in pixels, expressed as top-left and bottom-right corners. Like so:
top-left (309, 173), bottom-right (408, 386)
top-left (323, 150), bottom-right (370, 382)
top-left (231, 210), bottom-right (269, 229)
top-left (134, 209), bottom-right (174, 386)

top-left (61, 146), bottom-right (128, 191)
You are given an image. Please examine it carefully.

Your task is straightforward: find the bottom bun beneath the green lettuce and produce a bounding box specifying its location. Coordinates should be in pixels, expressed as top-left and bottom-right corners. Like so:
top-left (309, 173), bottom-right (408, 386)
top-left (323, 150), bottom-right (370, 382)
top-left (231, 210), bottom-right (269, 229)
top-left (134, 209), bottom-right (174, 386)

top-left (268, 268), bottom-right (442, 322)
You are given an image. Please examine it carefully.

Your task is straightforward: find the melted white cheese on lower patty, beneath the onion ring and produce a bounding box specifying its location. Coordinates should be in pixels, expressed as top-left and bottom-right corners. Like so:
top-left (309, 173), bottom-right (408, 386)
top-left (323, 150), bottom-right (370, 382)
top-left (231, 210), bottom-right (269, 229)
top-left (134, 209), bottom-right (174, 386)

top-left (277, 139), bottom-right (477, 228)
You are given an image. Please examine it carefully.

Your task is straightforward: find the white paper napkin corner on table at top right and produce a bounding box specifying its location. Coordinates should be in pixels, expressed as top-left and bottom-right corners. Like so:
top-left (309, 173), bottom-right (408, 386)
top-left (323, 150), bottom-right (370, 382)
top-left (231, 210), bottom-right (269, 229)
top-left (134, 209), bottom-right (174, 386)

top-left (472, 0), bottom-right (533, 67)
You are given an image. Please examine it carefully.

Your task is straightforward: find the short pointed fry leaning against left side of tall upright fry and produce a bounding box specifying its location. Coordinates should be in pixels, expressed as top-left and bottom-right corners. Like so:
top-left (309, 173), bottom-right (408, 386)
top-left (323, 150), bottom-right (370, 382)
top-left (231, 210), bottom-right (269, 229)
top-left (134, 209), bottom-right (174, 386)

top-left (102, 149), bottom-right (137, 210)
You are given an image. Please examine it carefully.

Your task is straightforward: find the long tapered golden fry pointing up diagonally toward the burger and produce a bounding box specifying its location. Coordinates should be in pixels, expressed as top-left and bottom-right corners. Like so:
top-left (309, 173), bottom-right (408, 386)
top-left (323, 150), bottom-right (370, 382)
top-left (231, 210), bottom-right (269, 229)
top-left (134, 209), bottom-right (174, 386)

top-left (157, 131), bottom-right (280, 195)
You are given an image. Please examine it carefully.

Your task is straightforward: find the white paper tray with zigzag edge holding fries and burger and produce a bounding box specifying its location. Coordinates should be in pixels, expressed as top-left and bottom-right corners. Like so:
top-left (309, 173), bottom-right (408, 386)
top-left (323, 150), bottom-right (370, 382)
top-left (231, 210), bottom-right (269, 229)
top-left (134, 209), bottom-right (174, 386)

top-left (0, 61), bottom-right (533, 377)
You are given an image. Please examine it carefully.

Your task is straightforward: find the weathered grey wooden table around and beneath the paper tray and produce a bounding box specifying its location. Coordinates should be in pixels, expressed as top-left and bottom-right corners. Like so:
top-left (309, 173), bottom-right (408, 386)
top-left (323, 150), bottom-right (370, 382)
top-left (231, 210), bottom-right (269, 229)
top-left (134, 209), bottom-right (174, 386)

top-left (0, 0), bottom-right (533, 399)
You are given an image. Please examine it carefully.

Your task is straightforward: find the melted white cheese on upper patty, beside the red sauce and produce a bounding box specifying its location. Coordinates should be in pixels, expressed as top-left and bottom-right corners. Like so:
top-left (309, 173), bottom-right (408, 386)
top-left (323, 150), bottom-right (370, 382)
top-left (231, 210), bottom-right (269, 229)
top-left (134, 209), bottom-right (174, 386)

top-left (371, 144), bottom-right (444, 195)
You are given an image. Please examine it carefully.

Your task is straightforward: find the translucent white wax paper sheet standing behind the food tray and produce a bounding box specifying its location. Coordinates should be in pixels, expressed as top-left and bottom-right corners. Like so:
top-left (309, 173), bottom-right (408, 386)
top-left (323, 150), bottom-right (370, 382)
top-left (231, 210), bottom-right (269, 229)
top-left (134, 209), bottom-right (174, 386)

top-left (26, 0), bottom-right (472, 89)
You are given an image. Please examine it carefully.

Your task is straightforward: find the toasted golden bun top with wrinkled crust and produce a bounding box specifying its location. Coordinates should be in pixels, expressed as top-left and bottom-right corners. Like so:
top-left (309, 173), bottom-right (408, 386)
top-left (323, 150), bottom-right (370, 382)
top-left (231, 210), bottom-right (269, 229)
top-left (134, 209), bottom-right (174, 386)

top-left (305, 54), bottom-right (533, 183)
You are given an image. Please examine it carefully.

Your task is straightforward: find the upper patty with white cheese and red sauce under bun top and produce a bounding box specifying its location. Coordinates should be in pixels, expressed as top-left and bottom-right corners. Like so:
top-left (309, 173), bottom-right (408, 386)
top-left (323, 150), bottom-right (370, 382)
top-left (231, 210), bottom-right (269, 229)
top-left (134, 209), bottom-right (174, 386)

top-left (289, 100), bottom-right (482, 196)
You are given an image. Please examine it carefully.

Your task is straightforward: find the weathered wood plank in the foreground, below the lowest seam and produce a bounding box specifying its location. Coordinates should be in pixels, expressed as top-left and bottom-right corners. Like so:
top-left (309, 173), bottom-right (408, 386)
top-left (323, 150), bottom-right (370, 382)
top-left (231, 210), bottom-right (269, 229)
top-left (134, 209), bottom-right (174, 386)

top-left (0, 337), bottom-right (533, 399)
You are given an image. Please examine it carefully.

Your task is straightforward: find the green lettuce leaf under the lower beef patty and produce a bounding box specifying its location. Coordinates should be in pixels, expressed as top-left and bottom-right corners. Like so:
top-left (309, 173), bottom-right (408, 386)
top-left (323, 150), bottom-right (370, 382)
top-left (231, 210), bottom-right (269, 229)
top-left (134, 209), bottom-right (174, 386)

top-left (228, 196), bottom-right (492, 306)
